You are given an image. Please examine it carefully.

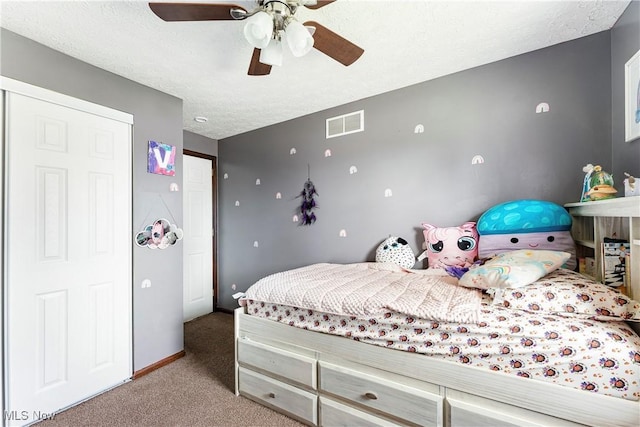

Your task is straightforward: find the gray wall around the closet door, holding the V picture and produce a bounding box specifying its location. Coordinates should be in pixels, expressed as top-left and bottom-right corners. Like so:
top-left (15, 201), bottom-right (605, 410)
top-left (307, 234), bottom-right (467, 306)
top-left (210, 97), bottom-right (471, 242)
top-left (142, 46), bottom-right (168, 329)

top-left (0, 29), bottom-right (183, 371)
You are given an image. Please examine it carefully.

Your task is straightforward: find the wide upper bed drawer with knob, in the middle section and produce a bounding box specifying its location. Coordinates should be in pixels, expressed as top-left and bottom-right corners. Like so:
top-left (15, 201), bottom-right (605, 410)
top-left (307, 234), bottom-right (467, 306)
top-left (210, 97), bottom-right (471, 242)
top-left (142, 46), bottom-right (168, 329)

top-left (320, 362), bottom-right (444, 426)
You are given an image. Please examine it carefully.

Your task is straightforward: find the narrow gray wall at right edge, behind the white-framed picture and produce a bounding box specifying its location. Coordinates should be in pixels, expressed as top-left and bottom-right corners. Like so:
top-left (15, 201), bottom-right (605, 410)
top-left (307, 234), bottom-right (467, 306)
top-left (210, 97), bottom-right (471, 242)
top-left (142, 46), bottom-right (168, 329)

top-left (611, 0), bottom-right (640, 181)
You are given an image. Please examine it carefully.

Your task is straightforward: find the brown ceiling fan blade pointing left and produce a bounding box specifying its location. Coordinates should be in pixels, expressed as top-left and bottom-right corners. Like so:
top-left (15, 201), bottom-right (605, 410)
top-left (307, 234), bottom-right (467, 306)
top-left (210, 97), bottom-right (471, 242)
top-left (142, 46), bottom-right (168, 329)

top-left (149, 3), bottom-right (247, 21)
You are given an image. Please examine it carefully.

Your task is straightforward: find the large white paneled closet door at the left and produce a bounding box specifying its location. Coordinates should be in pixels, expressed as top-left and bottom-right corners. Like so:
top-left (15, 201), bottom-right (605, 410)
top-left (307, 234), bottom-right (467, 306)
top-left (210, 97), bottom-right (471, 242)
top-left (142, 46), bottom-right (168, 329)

top-left (5, 89), bottom-right (133, 425)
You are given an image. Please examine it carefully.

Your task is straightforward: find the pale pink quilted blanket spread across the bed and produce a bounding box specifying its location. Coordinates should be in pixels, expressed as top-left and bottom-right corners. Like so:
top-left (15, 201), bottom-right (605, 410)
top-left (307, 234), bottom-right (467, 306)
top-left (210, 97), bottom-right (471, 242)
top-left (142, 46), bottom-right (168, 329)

top-left (244, 263), bottom-right (482, 323)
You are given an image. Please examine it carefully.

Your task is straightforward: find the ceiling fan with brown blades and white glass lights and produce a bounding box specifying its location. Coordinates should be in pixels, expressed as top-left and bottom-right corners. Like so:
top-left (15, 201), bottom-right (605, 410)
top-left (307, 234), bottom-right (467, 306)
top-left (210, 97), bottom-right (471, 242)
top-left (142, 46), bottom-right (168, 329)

top-left (149, 0), bottom-right (364, 76)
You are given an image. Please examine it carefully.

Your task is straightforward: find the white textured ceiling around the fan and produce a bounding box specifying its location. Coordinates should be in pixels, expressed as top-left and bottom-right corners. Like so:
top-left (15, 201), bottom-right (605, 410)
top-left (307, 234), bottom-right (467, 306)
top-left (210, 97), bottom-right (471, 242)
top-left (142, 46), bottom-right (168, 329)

top-left (0, 0), bottom-right (629, 139)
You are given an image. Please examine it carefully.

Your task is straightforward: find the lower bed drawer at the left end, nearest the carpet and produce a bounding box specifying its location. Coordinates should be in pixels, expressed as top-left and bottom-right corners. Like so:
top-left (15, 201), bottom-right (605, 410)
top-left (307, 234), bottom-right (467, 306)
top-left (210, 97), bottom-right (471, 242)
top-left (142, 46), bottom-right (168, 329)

top-left (238, 367), bottom-right (318, 425)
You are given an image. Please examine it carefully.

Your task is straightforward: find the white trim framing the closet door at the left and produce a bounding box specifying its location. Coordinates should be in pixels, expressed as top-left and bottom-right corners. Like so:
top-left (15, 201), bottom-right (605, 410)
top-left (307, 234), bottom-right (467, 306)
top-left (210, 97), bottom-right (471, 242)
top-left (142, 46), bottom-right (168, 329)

top-left (0, 76), bottom-right (133, 426)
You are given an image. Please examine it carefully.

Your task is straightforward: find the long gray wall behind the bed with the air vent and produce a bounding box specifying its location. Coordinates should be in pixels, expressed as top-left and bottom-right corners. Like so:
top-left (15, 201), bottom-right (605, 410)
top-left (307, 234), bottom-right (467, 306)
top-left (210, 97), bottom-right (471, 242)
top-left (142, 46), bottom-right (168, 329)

top-left (218, 31), bottom-right (612, 308)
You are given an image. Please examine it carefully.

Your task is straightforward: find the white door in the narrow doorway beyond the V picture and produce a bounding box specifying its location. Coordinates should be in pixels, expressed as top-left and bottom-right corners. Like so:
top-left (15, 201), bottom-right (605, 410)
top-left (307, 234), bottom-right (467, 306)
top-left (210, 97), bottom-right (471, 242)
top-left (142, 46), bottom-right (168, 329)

top-left (182, 156), bottom-right (213, 322)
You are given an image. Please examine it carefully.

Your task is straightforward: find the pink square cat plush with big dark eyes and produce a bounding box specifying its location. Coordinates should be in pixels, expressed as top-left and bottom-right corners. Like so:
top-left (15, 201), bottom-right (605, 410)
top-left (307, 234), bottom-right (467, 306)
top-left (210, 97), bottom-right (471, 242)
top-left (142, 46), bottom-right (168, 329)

top-left (422, 222), bottom-right (478, 269)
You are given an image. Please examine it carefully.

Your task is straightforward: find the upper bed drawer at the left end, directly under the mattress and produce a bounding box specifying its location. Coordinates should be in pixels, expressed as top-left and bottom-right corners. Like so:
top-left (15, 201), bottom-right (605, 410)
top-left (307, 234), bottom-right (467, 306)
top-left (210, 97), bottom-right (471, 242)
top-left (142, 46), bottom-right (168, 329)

top-left (238, 339), bottom-right (317, 390)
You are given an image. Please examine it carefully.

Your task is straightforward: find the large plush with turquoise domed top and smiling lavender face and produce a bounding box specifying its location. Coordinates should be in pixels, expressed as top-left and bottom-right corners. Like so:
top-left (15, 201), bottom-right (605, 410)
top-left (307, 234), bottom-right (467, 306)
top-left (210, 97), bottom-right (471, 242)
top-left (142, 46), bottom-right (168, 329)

top-left (478, 200), bottom-right (576, 269)
